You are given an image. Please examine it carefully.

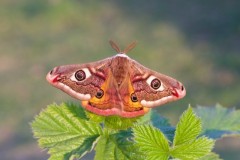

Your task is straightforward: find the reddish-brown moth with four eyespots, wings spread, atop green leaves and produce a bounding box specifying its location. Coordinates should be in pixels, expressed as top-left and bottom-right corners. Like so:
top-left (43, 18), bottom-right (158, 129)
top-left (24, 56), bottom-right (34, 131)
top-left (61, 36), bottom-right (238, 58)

top-left (46, 41), bottom-right (186, 118)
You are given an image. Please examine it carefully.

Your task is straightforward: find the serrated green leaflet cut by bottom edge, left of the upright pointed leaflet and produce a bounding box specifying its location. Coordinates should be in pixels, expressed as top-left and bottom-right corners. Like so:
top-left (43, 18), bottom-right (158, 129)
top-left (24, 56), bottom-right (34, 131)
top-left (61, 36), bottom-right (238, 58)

top-left (133, 125), bottom-right (169, 160)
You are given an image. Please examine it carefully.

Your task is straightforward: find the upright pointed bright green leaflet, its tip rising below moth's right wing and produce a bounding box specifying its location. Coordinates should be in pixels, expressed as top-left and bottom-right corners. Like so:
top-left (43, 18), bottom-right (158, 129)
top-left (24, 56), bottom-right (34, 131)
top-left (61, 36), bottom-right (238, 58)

top-left (173, 106), bottom-right (202, 146)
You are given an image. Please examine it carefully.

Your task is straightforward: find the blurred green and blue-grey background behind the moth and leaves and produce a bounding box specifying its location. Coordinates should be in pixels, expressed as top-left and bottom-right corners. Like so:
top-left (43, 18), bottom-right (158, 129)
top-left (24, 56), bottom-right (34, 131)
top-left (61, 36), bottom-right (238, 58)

top-left (0, 0), bottom-right (240, 160)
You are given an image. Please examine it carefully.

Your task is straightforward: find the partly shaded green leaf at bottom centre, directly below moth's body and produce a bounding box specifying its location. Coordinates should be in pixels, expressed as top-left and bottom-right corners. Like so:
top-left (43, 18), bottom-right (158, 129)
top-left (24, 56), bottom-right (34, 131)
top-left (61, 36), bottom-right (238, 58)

top-left (94, 131), bottom-right (143, 160)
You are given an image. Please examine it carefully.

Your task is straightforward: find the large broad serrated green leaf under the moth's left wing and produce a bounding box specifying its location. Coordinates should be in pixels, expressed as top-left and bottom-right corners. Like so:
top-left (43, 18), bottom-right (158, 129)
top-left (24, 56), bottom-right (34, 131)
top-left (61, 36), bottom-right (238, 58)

top-left (31, 103), bottom-right (102, 159)
